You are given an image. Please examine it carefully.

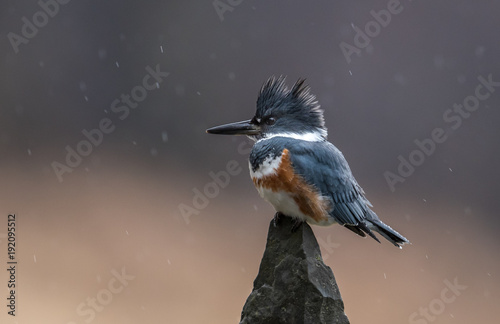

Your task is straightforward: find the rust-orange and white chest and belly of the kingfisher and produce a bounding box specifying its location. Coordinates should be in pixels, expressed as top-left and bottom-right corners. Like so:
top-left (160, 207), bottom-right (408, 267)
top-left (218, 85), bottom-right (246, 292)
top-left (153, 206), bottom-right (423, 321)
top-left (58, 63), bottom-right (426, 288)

top-left (250, 149), bottom-right (329, 224)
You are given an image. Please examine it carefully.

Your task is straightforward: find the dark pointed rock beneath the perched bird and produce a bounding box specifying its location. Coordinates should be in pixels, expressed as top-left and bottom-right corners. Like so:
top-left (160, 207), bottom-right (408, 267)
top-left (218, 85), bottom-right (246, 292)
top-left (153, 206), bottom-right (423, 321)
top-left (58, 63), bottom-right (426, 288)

top-left (240, 217), bottom-right (349, 324)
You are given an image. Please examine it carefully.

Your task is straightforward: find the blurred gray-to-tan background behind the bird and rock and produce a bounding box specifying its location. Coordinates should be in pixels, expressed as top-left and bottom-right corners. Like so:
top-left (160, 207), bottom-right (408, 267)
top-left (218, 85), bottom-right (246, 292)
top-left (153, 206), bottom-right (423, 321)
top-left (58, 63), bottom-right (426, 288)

top-left (0, 0), bottom-right (500, 324)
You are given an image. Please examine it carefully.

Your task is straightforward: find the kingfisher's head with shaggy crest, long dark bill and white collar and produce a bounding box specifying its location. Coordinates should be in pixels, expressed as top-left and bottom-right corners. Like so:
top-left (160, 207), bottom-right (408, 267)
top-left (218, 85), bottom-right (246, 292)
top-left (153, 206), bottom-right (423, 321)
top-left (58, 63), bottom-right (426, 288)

top-left (207, 76), bottom-right (327, 140)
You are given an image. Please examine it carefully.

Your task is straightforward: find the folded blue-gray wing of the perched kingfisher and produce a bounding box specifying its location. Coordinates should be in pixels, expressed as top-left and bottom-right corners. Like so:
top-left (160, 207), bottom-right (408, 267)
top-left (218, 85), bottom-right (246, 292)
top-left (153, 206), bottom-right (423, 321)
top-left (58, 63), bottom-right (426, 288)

top-left (287, 141), bottom-right (371, 228)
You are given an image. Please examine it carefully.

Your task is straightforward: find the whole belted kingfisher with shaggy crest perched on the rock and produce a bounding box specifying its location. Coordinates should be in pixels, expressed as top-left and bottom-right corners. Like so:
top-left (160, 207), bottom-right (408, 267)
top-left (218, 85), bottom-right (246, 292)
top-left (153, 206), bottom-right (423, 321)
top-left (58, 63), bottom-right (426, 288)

top-left (207, 76), bottom-right (409, 248)
